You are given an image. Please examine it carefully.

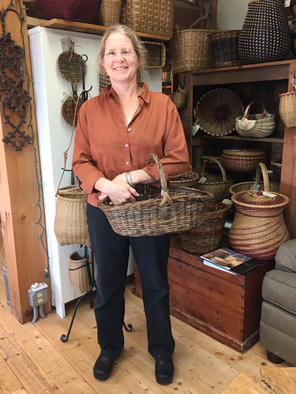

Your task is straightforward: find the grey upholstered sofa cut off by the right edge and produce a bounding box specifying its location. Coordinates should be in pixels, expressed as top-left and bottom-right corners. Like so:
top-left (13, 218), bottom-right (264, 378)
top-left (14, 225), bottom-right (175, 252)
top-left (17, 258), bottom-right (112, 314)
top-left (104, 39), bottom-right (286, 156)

top-left (260, 239), bottom-right (296, 365)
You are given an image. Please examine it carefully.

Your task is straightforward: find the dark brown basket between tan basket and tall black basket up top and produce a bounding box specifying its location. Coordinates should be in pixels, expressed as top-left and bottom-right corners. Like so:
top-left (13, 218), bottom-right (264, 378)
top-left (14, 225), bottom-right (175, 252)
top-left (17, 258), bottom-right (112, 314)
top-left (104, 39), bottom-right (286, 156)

top-left (209, 30), bottom-right (240, 67)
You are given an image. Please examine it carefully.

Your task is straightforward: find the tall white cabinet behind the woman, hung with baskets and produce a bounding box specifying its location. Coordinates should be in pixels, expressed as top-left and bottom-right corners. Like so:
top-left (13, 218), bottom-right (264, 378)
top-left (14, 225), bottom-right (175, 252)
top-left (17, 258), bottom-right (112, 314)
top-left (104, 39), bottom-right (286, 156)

top-left (28, 26), bottom-right (162, 317)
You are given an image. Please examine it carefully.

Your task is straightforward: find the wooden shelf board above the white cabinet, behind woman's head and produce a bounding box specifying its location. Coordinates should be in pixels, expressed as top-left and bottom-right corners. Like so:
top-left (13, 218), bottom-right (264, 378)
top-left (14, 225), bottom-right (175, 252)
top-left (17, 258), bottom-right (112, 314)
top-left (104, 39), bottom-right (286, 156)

top-left (27, 16), bottom-right (170, 41)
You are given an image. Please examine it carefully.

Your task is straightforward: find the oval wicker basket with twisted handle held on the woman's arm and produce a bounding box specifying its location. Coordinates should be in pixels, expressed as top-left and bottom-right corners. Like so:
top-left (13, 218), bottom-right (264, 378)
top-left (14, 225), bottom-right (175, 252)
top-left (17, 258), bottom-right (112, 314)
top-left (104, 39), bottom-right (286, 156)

top-left (98, 153), bottom-right (213, 237)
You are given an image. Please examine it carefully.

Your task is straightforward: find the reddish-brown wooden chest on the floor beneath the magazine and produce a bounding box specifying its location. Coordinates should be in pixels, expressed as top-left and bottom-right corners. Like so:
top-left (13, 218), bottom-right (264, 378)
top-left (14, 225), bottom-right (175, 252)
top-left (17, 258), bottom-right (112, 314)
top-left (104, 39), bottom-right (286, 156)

top-left (133, 238), bottom-right (274, 352)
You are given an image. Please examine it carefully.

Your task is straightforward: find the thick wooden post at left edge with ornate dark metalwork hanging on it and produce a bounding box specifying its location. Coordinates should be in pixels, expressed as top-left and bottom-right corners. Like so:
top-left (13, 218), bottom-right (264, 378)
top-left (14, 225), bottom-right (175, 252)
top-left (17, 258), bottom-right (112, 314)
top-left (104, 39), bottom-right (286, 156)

top-left (0, 0), bottom-right (50, 323)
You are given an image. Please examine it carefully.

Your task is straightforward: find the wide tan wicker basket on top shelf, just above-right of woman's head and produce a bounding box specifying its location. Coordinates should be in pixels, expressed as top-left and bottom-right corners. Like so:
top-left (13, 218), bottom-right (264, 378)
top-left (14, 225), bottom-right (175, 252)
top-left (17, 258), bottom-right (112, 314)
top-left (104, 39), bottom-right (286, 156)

top-left (121, 0), bottom-right (174, 37)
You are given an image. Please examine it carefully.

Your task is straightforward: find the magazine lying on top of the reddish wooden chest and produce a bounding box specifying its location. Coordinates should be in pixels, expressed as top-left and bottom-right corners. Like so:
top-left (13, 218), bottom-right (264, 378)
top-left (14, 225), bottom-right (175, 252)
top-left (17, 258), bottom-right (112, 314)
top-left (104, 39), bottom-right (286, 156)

top-left (200, 248), bottom-right (262, 275)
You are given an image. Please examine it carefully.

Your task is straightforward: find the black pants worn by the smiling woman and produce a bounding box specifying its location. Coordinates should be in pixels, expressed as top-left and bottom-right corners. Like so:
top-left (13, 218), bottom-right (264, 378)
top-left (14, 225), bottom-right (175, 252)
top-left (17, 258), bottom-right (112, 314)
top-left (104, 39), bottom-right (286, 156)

top-left (86, 204), bottom-right (175, 360)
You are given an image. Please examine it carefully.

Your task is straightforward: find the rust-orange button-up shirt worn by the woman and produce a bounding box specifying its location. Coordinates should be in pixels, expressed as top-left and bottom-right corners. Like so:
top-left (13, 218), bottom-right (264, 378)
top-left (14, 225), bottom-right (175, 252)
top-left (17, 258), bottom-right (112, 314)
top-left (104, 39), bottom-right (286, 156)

top-left (72, 83), bottom-right (189, 206)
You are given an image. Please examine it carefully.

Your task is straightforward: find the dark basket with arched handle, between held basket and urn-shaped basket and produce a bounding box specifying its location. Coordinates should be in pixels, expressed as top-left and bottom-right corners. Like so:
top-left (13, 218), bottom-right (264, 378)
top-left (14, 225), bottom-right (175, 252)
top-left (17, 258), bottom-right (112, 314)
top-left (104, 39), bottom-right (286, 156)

top-left (196, 159), bottom-right (233, 201)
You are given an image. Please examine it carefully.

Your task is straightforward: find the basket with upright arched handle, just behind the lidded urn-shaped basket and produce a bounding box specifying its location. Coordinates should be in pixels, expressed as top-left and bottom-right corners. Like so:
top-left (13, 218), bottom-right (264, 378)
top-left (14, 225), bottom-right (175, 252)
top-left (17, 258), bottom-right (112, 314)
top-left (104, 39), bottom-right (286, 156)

top-left (229, 163), bottom-right (280, 194)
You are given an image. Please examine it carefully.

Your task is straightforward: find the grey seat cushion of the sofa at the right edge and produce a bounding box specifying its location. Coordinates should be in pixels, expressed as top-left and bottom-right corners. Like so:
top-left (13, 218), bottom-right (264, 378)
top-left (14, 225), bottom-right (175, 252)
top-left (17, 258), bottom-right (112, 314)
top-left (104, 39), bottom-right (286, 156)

top-left (262, 269), bottom-right (296, 315)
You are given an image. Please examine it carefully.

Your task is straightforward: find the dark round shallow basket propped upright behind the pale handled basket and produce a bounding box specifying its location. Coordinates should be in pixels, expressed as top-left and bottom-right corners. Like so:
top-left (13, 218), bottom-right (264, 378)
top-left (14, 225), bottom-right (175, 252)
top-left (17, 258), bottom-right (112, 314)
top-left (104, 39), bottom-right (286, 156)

top-left (195, 88), bottom-right (243, 137)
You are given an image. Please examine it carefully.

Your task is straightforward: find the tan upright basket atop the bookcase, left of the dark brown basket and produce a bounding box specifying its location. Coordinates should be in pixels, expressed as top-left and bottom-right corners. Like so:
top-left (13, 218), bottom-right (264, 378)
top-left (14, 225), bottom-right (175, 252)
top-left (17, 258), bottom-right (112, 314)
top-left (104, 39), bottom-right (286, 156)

top-left (170, 29), bottom-right (216, 74)
